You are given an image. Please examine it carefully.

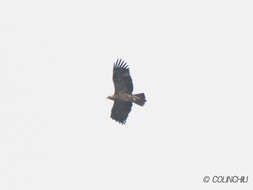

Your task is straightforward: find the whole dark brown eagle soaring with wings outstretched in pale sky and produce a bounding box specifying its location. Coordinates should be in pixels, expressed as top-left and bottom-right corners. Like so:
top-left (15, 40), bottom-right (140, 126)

top-left (107, 59), bottom-right (146, 124)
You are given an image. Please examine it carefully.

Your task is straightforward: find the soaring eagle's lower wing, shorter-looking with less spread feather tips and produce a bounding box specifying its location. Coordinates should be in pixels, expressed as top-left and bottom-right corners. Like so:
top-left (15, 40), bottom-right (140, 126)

top-left (111, 100), bottom-right (132, 124)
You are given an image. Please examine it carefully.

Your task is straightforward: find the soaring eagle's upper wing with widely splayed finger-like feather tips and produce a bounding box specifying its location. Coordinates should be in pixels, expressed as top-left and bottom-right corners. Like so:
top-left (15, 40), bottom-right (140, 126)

top-left (112, 59), bottom-right (133, 94)
